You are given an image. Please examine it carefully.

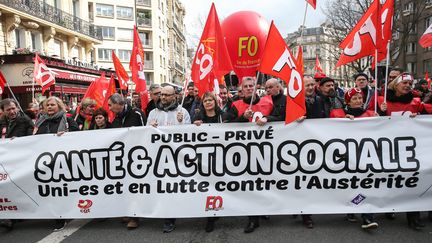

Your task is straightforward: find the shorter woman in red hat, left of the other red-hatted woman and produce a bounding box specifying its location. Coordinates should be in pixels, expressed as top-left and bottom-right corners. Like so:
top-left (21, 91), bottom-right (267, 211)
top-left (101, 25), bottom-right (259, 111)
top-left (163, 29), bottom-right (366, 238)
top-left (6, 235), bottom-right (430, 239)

top-left (330, 88), bottom-right (375, 120)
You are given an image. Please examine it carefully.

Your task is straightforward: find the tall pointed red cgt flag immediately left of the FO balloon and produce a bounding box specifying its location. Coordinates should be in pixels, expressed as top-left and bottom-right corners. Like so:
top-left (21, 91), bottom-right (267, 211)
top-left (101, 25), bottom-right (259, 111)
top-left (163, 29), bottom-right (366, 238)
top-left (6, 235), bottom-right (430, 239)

top-left (191, 3), bottom-right (233, 96)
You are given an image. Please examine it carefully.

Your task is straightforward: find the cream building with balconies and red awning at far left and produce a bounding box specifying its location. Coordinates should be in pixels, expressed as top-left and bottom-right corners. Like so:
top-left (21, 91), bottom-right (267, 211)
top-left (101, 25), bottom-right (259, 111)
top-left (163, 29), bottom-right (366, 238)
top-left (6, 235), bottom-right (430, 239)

top-left (0, 0), bottom-right (115, 107)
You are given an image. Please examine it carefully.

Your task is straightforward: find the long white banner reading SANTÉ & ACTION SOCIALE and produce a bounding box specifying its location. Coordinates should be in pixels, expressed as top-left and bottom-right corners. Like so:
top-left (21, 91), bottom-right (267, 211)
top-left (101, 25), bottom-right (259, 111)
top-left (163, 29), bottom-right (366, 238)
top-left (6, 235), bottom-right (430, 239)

top-left (0, 116), bottom-right (432, 218)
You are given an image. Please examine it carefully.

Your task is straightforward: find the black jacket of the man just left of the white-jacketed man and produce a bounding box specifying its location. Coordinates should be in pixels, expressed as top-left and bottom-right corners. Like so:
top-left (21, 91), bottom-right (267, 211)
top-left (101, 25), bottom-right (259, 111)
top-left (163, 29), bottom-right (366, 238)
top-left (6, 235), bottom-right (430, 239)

top-left (111, 104), bottom-right (147, 128)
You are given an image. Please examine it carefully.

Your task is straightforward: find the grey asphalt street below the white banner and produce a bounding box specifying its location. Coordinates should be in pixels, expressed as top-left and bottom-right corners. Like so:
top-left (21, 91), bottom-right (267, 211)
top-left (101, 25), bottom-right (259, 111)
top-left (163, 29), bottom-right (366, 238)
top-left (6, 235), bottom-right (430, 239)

top-left (0, 213), bottom-right (432, 243)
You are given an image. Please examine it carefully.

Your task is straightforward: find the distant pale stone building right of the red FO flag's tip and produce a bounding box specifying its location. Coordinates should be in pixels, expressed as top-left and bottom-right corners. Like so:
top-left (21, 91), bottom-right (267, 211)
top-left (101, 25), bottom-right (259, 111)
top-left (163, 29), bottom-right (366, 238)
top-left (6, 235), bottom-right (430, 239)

top-left (285, 24), bottom-right (353, 87)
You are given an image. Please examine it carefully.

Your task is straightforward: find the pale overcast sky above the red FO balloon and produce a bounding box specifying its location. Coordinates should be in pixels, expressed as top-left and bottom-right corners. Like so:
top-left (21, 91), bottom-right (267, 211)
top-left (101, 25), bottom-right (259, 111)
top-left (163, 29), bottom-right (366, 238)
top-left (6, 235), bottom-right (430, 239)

top-left (181, 0), bottom-right (328, 47)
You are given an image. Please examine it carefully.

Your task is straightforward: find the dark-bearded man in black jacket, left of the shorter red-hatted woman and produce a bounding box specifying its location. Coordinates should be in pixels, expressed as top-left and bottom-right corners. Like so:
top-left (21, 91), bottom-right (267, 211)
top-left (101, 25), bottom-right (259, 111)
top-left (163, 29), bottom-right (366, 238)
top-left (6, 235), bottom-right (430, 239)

top-left (318, 77), bottom-right (344, 118)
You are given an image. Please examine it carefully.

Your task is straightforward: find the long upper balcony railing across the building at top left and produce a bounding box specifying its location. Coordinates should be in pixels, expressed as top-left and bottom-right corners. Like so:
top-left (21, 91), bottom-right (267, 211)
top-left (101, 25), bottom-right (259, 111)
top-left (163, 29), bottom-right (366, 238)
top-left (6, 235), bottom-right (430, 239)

top-left (0, 0), bottom-right (102, 40)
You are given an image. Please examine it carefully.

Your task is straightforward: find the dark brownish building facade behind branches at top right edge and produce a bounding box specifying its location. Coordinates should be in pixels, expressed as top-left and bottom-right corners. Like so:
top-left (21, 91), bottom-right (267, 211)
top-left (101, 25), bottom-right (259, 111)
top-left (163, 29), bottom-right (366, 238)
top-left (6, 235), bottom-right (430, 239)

top-left (391, 0), bottom-right (432, 78)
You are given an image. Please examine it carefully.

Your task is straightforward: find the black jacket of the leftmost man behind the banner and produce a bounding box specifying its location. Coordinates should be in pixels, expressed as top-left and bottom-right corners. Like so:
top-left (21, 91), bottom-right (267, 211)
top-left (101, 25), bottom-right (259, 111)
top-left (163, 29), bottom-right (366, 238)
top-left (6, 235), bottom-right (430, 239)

top-left (0, 114), bottom-right (34, 138)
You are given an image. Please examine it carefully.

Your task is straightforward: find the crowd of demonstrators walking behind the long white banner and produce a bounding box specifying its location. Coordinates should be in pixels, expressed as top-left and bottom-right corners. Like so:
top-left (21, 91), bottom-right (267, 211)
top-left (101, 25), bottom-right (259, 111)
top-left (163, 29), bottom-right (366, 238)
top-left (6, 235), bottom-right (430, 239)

top-left (0, 72), bottom-right (432, 233)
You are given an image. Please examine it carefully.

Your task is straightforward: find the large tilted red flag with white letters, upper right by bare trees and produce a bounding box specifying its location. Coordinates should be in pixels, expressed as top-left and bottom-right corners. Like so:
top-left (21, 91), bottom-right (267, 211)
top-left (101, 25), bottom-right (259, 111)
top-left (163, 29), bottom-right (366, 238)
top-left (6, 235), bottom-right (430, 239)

top-left (336, 0), bottom-right (382, 67)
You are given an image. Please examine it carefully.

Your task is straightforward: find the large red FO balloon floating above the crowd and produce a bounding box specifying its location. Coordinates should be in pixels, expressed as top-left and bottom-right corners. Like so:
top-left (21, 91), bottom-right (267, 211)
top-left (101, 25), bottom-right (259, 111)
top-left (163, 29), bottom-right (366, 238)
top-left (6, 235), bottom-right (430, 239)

top-left (221, 11), bottom-right (270, 82)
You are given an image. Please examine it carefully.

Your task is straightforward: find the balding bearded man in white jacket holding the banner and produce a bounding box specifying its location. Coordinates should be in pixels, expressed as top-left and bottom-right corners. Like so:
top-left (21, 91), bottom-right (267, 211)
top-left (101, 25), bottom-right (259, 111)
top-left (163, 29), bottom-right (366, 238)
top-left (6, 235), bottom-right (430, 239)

top-left (147, 85), bottom-right (191, 233)
